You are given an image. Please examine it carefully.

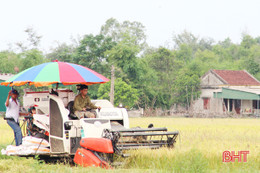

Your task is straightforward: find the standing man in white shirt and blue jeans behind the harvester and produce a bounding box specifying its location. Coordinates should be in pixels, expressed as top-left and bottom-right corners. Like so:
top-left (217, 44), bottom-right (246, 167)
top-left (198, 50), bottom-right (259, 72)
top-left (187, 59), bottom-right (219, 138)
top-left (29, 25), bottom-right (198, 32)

top-left (5, 89), bottom-right (23, 146)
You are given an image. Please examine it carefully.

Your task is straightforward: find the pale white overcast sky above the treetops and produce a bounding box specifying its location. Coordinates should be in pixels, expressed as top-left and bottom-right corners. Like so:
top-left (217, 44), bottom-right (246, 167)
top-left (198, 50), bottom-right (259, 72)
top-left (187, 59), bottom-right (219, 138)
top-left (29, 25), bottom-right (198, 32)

top-left (0, 0), bottom-right (260, 52)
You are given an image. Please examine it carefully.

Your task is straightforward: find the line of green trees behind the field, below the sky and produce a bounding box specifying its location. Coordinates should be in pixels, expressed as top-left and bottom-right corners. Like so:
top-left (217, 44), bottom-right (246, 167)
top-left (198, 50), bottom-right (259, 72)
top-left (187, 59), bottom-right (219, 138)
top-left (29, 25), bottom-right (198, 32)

top-left (0, 18), bottom-right (260, 109)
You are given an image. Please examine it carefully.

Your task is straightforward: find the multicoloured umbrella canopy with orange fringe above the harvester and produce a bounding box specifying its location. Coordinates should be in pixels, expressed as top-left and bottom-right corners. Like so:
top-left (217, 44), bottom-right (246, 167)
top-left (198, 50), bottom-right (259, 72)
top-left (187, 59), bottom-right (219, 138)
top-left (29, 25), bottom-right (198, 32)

top-left (1, 60), bottom-right (109, 87)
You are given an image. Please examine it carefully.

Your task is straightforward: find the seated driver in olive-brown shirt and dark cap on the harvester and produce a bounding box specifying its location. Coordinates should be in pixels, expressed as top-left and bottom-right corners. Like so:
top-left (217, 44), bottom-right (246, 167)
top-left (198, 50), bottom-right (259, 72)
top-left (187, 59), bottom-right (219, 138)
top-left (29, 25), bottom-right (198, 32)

top-left (73, 85), bottom-right (101, 119)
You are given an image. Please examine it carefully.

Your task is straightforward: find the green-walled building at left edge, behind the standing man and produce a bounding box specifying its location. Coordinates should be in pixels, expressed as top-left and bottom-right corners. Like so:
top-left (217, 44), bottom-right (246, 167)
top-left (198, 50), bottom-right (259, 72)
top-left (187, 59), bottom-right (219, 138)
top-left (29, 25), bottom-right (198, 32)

top-left (0, 73), bottom-right (14, 112)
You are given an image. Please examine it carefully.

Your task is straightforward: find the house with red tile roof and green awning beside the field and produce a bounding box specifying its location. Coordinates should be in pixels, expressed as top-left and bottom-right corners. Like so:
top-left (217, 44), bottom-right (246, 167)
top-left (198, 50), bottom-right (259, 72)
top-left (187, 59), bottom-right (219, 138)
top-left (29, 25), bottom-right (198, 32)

top-left (192, 70), bottom-right (260, 116)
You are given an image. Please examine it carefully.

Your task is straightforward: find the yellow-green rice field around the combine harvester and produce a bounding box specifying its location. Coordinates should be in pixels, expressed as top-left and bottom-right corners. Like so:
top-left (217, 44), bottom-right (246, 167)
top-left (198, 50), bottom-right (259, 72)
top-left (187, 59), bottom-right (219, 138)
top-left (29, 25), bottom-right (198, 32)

top-left (0, 117), bottom-right (260, 173)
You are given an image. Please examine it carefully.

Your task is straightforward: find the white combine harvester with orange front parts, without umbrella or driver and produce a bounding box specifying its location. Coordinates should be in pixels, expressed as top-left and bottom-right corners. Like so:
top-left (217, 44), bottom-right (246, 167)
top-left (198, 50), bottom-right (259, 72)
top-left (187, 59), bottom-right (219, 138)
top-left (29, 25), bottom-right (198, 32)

top-left (23, 89), bottom-right (178, 168)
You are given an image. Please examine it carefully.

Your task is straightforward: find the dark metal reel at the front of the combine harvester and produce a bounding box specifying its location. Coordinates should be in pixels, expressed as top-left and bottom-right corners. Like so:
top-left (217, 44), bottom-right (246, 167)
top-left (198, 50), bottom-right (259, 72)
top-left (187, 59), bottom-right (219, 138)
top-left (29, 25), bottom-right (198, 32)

top-left (103, 127), bottom-right (179, 151)
